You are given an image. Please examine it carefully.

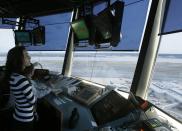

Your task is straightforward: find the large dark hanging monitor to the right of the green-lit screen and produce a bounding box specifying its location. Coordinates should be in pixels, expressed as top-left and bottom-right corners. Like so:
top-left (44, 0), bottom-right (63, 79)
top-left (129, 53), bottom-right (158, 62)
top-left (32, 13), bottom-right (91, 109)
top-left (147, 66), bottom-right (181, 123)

top-left (90, 1), bottom-right (124, 47)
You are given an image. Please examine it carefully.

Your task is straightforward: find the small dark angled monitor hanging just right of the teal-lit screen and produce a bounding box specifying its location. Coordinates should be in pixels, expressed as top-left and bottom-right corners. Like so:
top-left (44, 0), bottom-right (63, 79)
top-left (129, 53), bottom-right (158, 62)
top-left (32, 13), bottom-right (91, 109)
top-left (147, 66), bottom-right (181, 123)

top-left (32, 26), bottom-right (45, 45)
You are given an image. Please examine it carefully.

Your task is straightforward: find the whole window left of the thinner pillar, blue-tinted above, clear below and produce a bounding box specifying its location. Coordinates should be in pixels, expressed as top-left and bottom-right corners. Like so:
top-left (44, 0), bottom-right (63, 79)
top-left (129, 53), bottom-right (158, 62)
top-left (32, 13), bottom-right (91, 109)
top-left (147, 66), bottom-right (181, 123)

top-left (27, 12), bottom-right (71, 72)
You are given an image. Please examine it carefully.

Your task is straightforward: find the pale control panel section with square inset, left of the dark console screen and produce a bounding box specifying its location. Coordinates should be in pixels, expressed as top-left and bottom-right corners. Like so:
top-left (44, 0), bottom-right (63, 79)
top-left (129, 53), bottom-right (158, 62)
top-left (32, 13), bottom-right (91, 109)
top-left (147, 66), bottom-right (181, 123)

top-left (50, 76), bottom-right (103, 106)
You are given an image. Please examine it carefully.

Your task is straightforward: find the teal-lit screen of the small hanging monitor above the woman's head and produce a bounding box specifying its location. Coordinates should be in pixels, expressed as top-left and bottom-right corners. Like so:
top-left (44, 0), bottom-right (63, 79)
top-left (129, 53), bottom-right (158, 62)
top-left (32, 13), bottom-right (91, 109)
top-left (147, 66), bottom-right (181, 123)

top-left (14, 30), bottom-right (32, 43)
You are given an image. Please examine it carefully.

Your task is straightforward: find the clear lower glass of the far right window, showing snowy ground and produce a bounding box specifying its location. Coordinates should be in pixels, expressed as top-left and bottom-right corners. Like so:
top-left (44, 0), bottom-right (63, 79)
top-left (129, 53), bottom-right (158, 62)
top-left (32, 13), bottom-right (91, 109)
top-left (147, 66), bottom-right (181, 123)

top-left (148, 33), bottom-right (182, 121)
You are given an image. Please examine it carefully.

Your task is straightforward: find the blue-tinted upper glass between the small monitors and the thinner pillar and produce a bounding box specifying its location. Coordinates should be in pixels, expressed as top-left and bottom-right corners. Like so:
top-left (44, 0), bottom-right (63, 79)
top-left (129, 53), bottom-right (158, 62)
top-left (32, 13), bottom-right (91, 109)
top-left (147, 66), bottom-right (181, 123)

top-left (26, 12), bottom-right (71, 51)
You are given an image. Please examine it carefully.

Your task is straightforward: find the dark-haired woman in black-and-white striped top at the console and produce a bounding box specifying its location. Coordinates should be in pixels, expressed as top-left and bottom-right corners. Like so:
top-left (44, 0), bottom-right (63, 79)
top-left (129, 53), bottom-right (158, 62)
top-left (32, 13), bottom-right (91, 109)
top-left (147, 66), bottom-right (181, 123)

top-left (5, 46), bottom-right (36, 131)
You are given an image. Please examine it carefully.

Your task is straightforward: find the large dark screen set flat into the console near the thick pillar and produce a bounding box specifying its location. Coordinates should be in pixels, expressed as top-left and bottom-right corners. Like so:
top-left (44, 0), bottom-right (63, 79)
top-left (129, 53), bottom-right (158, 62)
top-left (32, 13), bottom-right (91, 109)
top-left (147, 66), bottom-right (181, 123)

top-left (91, 91), bottom-right (134, 125)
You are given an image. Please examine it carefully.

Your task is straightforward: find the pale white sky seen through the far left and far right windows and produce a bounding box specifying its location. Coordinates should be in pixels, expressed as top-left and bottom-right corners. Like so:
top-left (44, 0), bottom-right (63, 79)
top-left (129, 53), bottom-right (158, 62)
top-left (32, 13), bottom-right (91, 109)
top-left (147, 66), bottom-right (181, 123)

top-left (0, 29), bottom-right (182, 54)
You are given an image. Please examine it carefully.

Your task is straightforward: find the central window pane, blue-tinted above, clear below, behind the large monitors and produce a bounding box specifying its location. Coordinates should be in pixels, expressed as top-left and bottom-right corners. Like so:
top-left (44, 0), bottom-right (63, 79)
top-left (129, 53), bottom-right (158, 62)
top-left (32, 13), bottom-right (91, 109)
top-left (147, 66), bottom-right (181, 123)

top-left (72, 0), bottom-right (149, 91)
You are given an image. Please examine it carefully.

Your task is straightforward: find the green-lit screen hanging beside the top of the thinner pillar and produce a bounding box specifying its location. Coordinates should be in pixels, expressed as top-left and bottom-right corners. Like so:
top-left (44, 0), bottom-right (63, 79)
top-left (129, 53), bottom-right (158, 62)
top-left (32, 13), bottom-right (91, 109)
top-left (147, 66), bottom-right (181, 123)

top-left (71, 19), bottom-right (89, 40)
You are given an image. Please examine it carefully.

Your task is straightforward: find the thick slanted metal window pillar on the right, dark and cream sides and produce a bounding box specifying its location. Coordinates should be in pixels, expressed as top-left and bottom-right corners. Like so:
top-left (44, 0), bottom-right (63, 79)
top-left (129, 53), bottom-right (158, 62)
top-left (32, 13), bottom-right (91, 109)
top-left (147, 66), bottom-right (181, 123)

top-left (130, 0), bottom-right (166, 99)
